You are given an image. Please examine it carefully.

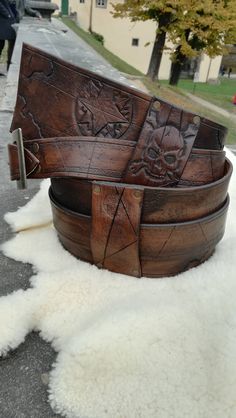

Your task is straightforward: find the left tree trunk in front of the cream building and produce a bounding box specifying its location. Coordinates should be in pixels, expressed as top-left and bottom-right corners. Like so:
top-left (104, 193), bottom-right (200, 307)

top-left (147, 15), bottom-right (170, 80)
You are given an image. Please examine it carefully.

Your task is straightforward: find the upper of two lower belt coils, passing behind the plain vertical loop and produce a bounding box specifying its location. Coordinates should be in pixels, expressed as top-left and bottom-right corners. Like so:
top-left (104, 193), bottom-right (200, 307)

top-left (51, 159), bottom-right (232, 224)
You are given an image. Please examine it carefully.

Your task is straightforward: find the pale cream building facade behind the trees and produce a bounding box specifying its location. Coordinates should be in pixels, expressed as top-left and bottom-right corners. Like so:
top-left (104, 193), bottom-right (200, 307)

top-left (58, 0), bottom-right (221, 82)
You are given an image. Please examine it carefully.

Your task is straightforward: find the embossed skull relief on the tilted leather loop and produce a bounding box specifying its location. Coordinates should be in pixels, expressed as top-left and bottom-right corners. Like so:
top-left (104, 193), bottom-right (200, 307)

top-left (130, 125), bottom-right (185, 182)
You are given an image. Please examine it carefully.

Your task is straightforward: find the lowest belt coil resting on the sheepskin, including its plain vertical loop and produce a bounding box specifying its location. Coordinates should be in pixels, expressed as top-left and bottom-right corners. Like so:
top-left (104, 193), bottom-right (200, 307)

top-left (49, 184), bottom-right (229, 278)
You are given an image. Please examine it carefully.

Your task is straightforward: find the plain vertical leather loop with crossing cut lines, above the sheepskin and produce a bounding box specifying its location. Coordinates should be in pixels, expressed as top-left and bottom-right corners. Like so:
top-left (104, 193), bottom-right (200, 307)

top-left (91, 182), bottom-right (144, 277)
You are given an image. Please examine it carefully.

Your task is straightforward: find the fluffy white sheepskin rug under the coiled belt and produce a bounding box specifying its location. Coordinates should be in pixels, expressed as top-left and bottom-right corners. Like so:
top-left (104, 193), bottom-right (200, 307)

top-left (0, 152), bottom-right (236, 418)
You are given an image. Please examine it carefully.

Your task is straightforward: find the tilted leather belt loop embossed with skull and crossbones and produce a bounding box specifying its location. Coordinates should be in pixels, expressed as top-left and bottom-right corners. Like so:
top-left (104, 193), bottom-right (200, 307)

top-left (123, 100), bottom-right (200, 186)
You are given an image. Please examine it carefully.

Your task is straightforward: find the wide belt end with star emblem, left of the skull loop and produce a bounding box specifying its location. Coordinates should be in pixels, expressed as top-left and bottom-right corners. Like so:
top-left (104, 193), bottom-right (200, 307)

top-left (11, 47), bottom-right (150, 140)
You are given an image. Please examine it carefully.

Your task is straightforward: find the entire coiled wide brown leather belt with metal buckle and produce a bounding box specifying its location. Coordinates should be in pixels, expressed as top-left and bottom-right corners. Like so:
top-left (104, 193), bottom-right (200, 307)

top-left (9, 45), bottom-right (232, 277)
